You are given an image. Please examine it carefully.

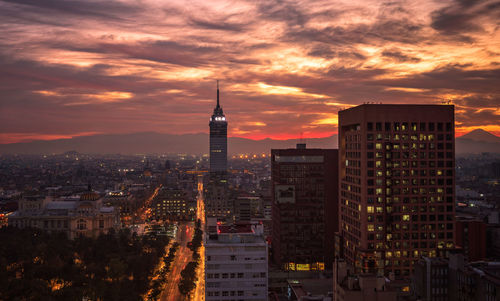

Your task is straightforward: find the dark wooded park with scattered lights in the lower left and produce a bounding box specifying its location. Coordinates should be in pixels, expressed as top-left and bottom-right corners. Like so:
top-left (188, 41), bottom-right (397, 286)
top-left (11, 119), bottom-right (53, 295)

top-left (0, 227), bottom-right (169, 300)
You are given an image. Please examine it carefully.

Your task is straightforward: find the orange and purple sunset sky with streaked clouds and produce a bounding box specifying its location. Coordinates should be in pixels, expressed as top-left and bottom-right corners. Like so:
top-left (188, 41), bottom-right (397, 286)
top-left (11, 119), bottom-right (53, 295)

top-left (0, 0), bottom-right (500, 143)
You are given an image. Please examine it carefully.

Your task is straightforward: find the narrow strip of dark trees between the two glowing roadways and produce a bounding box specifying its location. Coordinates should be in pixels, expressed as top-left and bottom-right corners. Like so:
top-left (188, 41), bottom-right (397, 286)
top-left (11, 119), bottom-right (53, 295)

top-left (179, 220), bottom-right (203, 296)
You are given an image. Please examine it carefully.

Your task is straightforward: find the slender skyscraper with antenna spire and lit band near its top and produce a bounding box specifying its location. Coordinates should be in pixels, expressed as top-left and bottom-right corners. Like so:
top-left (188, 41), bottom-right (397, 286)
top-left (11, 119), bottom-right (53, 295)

top-left (209, 81), bottom-right (227, 175)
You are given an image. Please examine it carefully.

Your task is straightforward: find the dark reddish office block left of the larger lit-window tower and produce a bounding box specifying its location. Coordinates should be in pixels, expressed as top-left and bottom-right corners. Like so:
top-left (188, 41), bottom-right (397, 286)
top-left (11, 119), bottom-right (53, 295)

top-left (271, 144), bottom-right (338, 270)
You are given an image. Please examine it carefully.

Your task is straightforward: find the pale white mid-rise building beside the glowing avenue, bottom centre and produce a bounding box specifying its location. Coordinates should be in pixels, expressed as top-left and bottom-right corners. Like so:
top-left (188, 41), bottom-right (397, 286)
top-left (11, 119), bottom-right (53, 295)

top-left (205, 218), bottom-right (268, 301)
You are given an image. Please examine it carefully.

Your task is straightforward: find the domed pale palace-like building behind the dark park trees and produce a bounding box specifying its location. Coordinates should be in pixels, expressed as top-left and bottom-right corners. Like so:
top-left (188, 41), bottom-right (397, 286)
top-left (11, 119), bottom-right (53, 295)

top-left (8, 192), bottom-right (120, 239)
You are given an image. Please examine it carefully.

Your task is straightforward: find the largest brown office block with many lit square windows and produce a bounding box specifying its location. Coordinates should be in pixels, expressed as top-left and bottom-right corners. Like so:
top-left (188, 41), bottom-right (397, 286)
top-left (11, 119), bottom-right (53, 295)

top-left (339, 104), bottom-right (455, 278)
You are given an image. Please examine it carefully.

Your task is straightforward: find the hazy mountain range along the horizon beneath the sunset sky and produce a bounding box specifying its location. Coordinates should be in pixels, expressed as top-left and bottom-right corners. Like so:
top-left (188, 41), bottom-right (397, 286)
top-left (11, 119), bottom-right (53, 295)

top-left (0, 129), bottom-right (500, 155)
